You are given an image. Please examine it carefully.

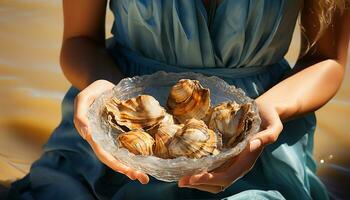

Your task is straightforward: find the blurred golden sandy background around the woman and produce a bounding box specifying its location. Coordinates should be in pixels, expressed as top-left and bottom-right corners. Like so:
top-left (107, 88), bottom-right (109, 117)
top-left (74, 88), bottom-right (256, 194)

top-left (0, 0), bottom-right (350, 198)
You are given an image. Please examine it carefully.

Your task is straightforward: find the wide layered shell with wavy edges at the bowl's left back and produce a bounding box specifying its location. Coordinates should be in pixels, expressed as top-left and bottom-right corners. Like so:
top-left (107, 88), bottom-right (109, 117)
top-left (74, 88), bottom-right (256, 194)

top-left (105, 95), bottom-right (165, 132)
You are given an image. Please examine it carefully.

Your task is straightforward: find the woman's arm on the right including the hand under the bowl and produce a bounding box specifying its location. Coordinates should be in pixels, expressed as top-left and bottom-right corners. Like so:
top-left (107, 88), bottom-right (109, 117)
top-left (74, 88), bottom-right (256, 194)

top-left (178, 5), bottom-right (350, 193)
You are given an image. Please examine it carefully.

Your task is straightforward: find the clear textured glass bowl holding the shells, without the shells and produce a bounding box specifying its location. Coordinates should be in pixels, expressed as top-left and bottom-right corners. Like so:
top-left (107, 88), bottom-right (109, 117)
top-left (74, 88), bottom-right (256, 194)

top-left (88, 72), bottom-right (261, 182)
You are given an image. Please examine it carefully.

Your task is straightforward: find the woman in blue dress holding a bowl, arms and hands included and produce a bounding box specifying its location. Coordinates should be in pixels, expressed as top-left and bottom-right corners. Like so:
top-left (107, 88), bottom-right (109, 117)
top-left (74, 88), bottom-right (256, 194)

top-left (11, 0), bottom-right (350, 199)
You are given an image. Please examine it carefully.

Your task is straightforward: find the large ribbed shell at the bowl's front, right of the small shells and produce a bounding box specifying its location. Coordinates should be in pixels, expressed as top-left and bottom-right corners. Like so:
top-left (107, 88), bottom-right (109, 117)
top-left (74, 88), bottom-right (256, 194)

top-left (168, 118), bottom-right (220, 158)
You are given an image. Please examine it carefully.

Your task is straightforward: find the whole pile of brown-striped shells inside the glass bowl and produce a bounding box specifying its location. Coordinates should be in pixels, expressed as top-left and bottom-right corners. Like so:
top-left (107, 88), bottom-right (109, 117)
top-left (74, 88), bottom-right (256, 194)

top-left (104, 79), bottom-right (254, 159)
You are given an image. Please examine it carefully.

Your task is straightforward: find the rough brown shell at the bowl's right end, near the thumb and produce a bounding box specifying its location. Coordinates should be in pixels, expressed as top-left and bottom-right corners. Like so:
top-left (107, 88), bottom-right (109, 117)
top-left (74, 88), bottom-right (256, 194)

top-left (206, 102), bottom-right (254, 147)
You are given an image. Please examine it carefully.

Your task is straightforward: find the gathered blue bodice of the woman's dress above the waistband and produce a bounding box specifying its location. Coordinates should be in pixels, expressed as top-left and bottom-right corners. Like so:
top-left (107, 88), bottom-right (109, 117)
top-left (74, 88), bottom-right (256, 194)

top-left (111, 0), bottom-right (302, 68)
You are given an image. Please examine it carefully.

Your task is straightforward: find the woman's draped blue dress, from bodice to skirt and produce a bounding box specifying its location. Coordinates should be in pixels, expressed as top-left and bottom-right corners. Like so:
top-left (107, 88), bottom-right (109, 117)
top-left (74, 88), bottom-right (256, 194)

top-left (11, 0), bottom-right (328, 200)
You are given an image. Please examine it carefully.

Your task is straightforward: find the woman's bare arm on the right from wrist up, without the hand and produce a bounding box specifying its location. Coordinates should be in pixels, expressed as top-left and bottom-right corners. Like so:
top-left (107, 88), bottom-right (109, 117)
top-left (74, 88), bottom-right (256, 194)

top-left (256, 5), bottom-right (350, 121)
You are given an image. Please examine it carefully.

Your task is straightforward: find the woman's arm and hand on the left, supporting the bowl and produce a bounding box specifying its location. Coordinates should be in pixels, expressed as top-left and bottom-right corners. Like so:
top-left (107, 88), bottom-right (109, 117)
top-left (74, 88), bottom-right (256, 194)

top-left (60, 0), bottom-right (149, 184)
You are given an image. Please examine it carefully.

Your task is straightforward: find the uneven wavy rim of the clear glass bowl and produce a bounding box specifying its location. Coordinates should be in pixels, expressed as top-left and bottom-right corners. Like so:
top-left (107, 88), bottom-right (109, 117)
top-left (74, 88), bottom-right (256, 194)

top-left (88, 71), bottom-right (261, 178)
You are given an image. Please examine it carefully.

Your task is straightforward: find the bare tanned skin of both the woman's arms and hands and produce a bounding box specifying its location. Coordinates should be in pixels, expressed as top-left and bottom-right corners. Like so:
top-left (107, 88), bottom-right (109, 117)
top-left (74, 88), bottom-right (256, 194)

top-left (60, 0), bottom-right (350, 193)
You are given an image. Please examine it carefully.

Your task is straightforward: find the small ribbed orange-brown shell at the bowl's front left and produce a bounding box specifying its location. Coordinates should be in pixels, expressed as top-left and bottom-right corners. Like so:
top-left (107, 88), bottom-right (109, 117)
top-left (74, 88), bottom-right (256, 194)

top-left (117, 130), bottom-right (155, 156)
